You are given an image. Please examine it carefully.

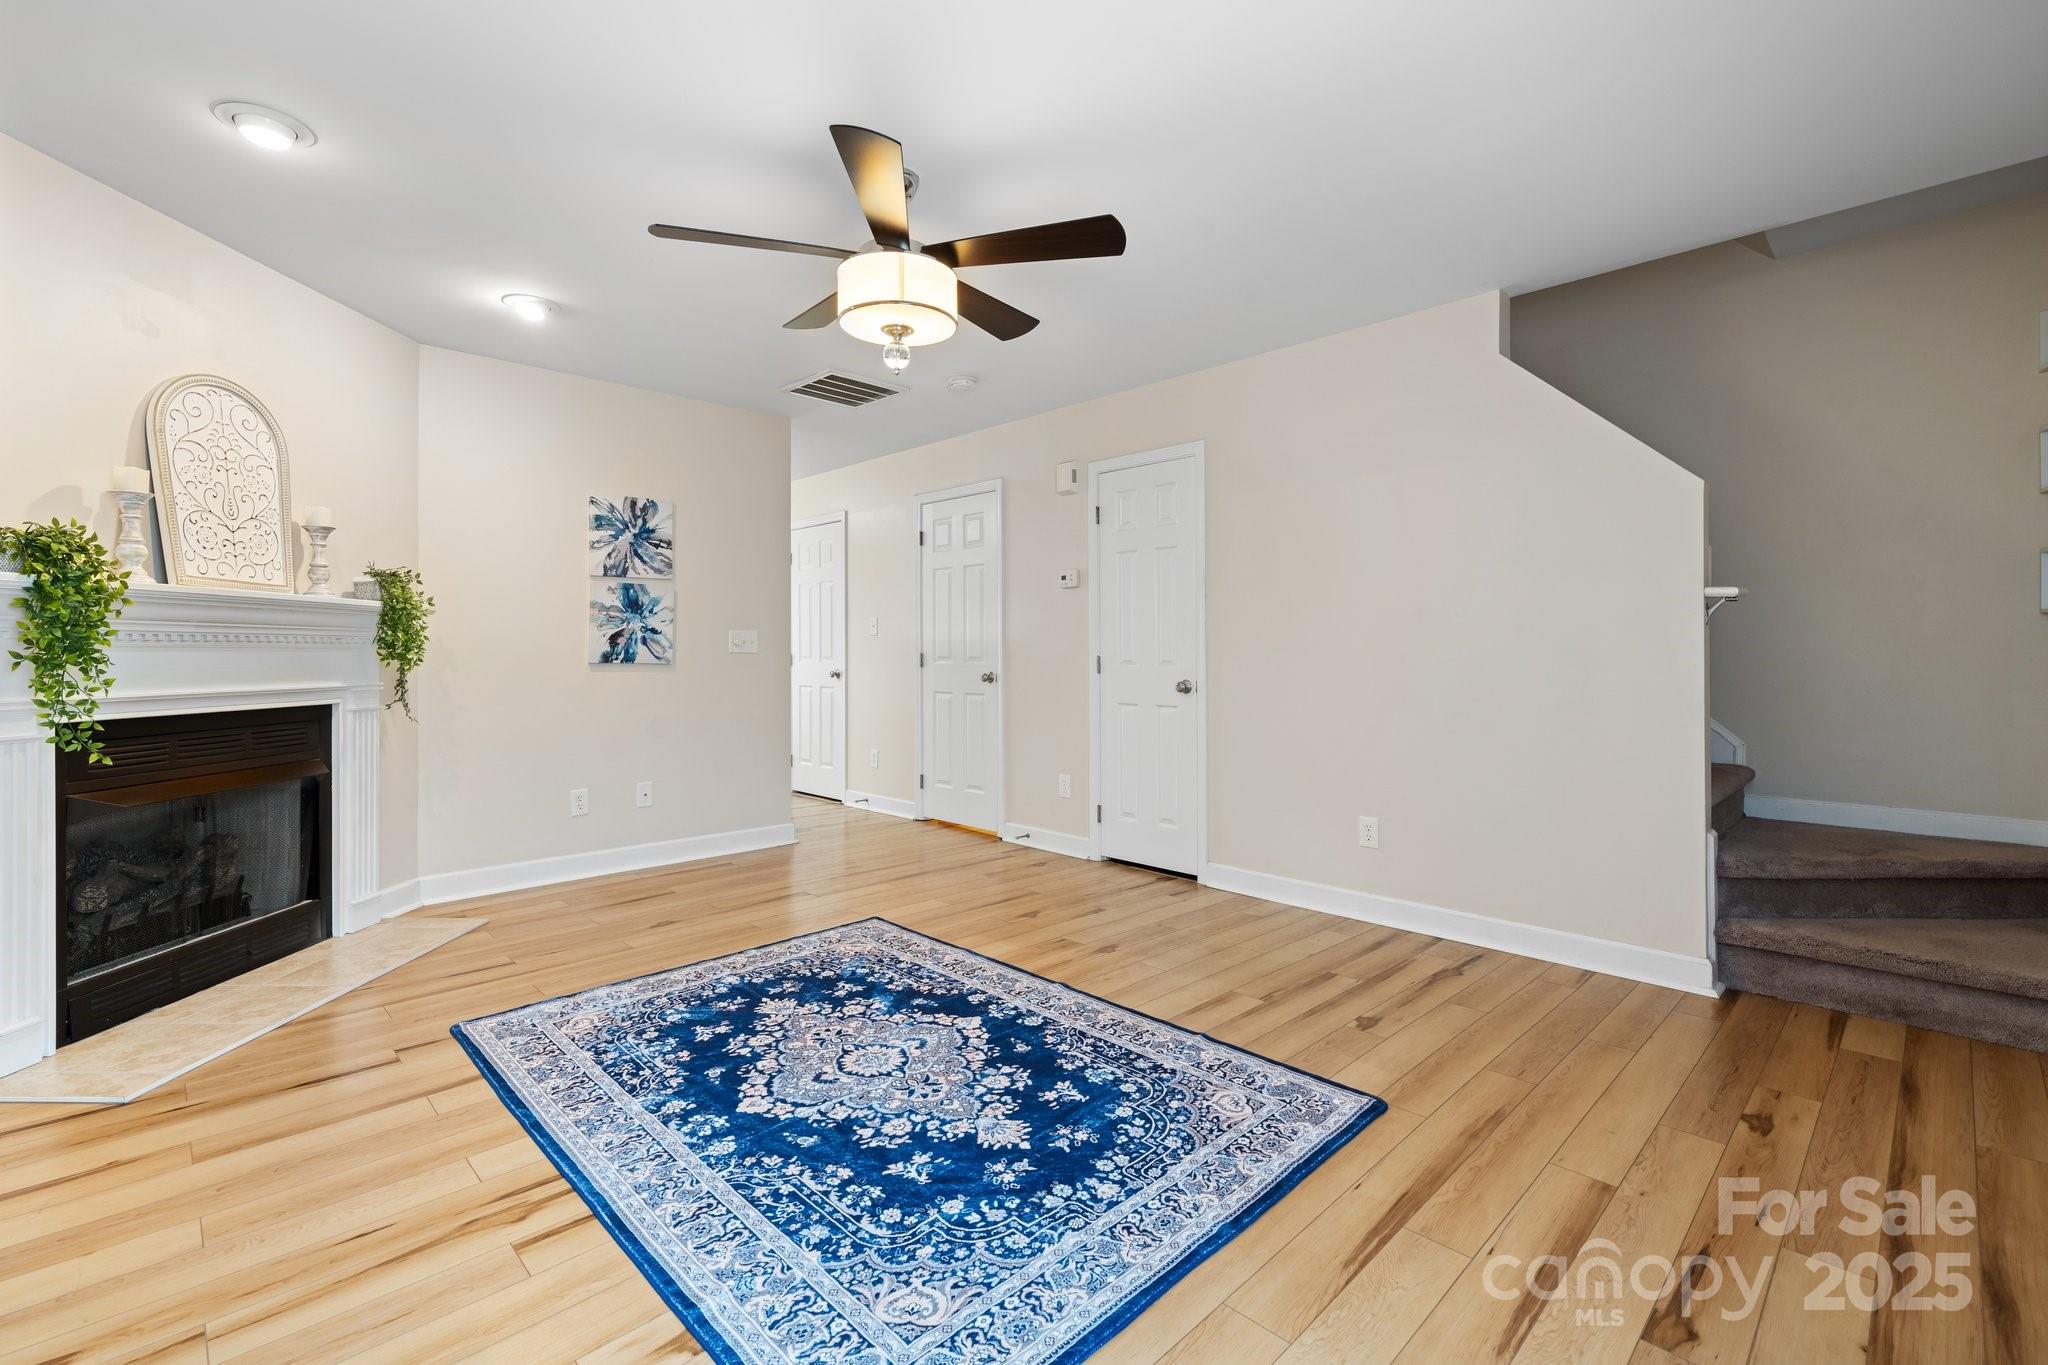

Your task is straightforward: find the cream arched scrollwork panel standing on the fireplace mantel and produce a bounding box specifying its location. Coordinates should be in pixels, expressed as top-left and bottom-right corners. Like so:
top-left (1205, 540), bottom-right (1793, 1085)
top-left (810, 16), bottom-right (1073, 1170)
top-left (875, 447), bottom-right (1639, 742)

top-left (143, 375), bottom-right (299, 593)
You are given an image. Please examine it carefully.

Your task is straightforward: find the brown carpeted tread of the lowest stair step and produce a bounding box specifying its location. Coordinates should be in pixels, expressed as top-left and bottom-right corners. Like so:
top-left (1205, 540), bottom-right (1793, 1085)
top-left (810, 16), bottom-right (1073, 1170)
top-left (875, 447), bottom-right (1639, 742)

top-left (1714, 919), bottom-right (2048, 1001)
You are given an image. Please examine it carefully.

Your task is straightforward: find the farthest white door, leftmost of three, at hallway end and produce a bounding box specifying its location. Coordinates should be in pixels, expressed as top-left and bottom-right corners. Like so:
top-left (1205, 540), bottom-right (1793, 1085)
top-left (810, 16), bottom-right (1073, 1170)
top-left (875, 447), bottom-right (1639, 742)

top-left (788, 514), bottom-right (846, 800)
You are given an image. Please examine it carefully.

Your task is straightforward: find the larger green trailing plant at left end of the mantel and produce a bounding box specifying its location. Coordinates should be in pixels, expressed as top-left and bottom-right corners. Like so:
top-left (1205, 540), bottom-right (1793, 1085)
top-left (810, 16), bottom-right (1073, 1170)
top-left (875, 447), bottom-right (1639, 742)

top-left (0, 518), bottom-right (129, 763)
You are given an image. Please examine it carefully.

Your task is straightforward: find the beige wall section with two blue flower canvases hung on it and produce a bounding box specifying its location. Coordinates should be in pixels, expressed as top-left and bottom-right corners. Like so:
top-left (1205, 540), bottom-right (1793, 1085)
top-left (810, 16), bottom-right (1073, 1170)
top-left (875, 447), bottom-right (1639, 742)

top-left (418, 348), bottom-right (788, 876)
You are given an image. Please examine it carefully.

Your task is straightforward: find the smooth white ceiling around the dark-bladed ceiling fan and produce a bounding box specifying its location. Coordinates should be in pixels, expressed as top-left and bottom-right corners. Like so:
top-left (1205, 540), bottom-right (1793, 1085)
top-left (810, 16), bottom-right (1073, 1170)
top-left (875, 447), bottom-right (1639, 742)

top-left (0, 0), bottom-right (2048, 473)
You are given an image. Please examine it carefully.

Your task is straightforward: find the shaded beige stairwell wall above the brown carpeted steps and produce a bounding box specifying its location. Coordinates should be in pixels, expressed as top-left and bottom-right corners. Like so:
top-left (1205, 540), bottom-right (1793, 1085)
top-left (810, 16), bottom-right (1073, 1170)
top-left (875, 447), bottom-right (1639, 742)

top-left (1513, 194), bottom-right (2048, 821)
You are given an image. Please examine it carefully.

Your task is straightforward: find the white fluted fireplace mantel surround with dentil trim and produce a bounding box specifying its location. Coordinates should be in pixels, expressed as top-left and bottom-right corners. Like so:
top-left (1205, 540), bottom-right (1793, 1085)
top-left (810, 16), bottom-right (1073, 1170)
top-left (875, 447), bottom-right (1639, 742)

top-left (0, 573), bottom-right (383, 1074)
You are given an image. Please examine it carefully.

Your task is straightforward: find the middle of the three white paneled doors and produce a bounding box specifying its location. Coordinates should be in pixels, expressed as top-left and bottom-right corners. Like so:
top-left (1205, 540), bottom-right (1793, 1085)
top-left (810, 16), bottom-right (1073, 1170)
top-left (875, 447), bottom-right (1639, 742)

top-left (918, 481), bottom-right (1004, 833)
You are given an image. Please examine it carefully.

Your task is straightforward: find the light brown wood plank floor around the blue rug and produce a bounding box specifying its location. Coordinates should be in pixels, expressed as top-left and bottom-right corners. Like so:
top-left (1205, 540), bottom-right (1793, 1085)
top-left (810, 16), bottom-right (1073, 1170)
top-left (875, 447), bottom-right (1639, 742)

top-left (0, 800), bottom-right (2048, 1365)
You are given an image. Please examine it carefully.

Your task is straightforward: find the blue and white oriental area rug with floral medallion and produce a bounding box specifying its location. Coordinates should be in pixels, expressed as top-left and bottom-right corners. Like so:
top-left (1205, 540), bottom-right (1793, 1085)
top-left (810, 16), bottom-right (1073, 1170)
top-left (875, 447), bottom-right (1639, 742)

top-left (455, 919), bottom-right (1386, 1365)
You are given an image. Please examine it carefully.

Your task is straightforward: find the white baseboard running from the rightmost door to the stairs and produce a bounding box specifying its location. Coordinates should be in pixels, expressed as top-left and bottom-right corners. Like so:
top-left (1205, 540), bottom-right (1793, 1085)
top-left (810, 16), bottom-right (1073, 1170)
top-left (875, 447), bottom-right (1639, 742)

top-left (1200, 864), bottom-right (1720, 995)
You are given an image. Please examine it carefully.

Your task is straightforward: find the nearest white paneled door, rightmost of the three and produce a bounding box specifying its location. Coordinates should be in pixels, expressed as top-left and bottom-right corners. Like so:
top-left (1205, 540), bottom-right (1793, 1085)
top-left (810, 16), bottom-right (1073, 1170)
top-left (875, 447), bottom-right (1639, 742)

top-left (1087, 442), bottom-right (1208, 874)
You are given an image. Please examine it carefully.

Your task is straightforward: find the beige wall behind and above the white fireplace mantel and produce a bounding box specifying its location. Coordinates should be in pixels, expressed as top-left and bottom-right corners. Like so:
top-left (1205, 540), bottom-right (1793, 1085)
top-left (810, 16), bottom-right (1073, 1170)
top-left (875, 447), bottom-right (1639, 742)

top-left (0, 137), bottom-right (420, 886)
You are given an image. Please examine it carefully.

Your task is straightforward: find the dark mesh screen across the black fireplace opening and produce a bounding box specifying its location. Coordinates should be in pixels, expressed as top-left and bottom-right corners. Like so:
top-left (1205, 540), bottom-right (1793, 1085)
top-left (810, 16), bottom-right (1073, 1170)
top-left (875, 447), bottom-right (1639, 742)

top-left (63, 778), bottom-right (319, 982)
